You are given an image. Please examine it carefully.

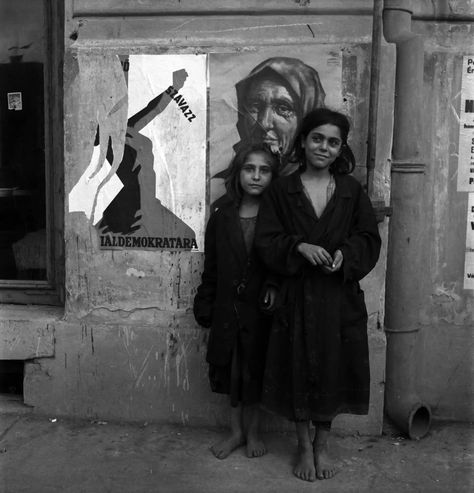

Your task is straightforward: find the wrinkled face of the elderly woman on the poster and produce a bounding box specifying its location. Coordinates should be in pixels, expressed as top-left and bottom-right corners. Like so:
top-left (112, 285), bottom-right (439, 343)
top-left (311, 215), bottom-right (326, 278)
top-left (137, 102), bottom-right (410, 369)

top-left (244, 77), bottom-right (298, 154)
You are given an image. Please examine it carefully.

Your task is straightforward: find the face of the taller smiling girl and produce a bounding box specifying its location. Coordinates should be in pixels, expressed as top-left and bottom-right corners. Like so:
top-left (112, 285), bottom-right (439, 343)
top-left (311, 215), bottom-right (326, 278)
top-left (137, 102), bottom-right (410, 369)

top-left (301, 123), bottom-right (342, 170)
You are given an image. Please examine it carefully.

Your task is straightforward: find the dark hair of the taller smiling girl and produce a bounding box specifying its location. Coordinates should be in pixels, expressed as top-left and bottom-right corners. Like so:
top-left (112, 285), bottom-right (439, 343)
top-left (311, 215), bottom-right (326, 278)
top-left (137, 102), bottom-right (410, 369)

top-left (295, 108), bottom-right (356, 175)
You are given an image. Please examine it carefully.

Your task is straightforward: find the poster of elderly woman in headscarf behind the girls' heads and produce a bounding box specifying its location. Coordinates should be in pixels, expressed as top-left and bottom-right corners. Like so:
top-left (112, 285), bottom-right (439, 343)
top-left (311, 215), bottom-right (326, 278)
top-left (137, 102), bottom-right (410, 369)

top-left (209, 45), bottom-right (343, 200)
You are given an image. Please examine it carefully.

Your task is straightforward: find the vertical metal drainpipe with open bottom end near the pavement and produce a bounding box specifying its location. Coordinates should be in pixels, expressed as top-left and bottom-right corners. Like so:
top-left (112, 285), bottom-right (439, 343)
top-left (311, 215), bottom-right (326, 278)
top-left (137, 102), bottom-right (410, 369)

top-left (383, 0), bottom-right (431, 439)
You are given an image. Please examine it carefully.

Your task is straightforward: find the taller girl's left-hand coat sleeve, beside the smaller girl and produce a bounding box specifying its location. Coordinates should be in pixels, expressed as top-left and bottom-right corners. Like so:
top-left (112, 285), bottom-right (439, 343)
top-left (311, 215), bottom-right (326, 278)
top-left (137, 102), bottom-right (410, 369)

top-left (255, 186), bottom-right (305, 276)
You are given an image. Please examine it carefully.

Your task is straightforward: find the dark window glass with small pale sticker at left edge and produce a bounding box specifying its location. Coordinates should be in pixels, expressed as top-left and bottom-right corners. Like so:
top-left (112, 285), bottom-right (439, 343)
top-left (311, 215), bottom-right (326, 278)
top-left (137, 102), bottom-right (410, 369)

top-left (0, 0), bottom-right (47, 280)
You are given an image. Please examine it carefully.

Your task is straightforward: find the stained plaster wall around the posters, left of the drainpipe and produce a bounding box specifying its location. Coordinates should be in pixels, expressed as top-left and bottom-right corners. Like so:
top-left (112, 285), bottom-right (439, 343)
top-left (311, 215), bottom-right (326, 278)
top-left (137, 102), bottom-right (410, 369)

top-left (4, 0), bottom-right (394, 434)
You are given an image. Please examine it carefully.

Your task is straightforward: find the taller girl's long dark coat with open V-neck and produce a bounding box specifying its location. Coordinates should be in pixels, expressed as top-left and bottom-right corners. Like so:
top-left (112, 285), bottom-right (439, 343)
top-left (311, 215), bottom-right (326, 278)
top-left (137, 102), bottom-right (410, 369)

top-left (255, 172), bottom-right (381, 421)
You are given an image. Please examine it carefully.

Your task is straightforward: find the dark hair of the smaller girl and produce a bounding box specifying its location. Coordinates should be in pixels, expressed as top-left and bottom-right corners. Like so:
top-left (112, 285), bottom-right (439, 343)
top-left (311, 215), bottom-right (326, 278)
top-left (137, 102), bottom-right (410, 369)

top-left (224, 144), bottom-right (280, 204)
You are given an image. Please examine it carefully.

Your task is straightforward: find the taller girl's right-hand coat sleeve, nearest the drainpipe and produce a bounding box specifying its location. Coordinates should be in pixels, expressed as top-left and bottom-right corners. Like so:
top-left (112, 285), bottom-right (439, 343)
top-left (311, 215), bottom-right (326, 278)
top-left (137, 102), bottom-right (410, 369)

top-left (339, 186), bottom-right (381, 281)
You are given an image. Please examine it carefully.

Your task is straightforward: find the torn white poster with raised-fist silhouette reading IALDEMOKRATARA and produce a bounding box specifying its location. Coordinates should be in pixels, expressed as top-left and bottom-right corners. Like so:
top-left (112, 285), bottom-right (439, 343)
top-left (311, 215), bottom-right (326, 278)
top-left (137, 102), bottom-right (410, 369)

top-left (69, 55), bottom-right (207, 251)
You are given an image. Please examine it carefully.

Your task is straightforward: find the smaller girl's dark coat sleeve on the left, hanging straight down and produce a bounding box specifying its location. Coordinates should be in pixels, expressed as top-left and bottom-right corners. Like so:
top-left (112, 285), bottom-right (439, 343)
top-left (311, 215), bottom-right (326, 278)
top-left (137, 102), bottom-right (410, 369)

top-left (193, 209), bottom-right (217, 328)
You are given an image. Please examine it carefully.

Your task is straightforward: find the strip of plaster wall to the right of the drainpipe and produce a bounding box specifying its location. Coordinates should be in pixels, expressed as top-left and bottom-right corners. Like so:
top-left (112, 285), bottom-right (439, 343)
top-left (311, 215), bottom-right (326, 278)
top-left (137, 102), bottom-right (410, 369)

top-left (413, 20), bottom-right (474, 420)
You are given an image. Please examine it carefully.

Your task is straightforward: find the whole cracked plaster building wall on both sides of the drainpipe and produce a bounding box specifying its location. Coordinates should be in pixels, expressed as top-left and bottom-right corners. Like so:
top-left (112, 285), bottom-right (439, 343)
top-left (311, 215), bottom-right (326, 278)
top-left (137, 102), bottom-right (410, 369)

top-left (0, 0), bottom-right (474, 433)
